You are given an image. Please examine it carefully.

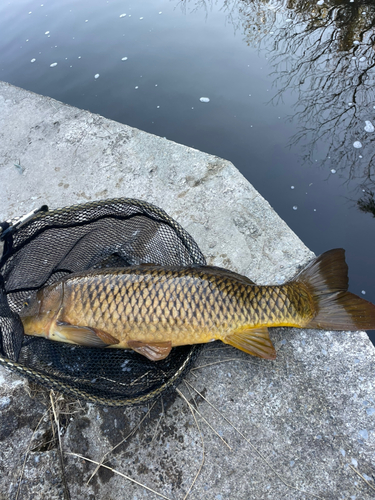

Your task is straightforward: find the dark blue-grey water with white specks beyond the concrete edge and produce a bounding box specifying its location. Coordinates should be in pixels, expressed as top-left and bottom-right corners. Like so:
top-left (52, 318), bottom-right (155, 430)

top-left (0, 0), bottom-right (375, 341)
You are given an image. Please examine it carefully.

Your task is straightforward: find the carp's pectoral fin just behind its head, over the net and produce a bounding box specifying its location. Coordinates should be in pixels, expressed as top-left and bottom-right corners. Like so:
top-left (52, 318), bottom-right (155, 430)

top-left (49, 321), bottom-right (119, 347)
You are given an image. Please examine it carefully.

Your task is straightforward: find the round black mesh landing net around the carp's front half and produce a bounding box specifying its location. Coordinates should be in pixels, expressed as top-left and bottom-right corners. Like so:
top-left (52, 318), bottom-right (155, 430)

top-left (0, 199), bottom-right (206, 406)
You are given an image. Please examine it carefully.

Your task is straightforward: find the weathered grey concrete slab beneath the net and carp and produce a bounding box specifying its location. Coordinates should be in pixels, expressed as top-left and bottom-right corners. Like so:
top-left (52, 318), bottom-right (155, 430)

top-left (0, 83), bottom-right (375, 500)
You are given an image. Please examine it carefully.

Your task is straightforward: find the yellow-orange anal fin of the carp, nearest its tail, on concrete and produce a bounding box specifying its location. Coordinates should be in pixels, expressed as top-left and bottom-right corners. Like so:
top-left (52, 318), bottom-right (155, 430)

top-left (222, 327), bottom-right (276, 359)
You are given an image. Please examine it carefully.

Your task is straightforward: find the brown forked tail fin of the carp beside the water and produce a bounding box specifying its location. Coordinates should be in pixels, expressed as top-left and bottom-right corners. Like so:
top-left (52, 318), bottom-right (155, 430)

top-left (295, 248), bottom-right (375, 330)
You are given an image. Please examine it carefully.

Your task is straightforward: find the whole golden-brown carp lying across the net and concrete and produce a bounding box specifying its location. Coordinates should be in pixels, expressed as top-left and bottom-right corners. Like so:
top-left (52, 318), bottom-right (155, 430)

top-left (20, 249), bottom-right (375, 360)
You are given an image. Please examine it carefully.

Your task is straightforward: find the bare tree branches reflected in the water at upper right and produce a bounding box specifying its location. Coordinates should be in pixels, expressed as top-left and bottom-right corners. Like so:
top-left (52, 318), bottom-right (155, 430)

top-left (180, 0), bottom-right (375, 199)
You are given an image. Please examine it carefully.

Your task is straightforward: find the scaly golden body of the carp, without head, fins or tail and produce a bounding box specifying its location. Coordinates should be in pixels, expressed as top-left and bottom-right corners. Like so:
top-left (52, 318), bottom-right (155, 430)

top-left (56, 267), bottom-right (311, 347)
